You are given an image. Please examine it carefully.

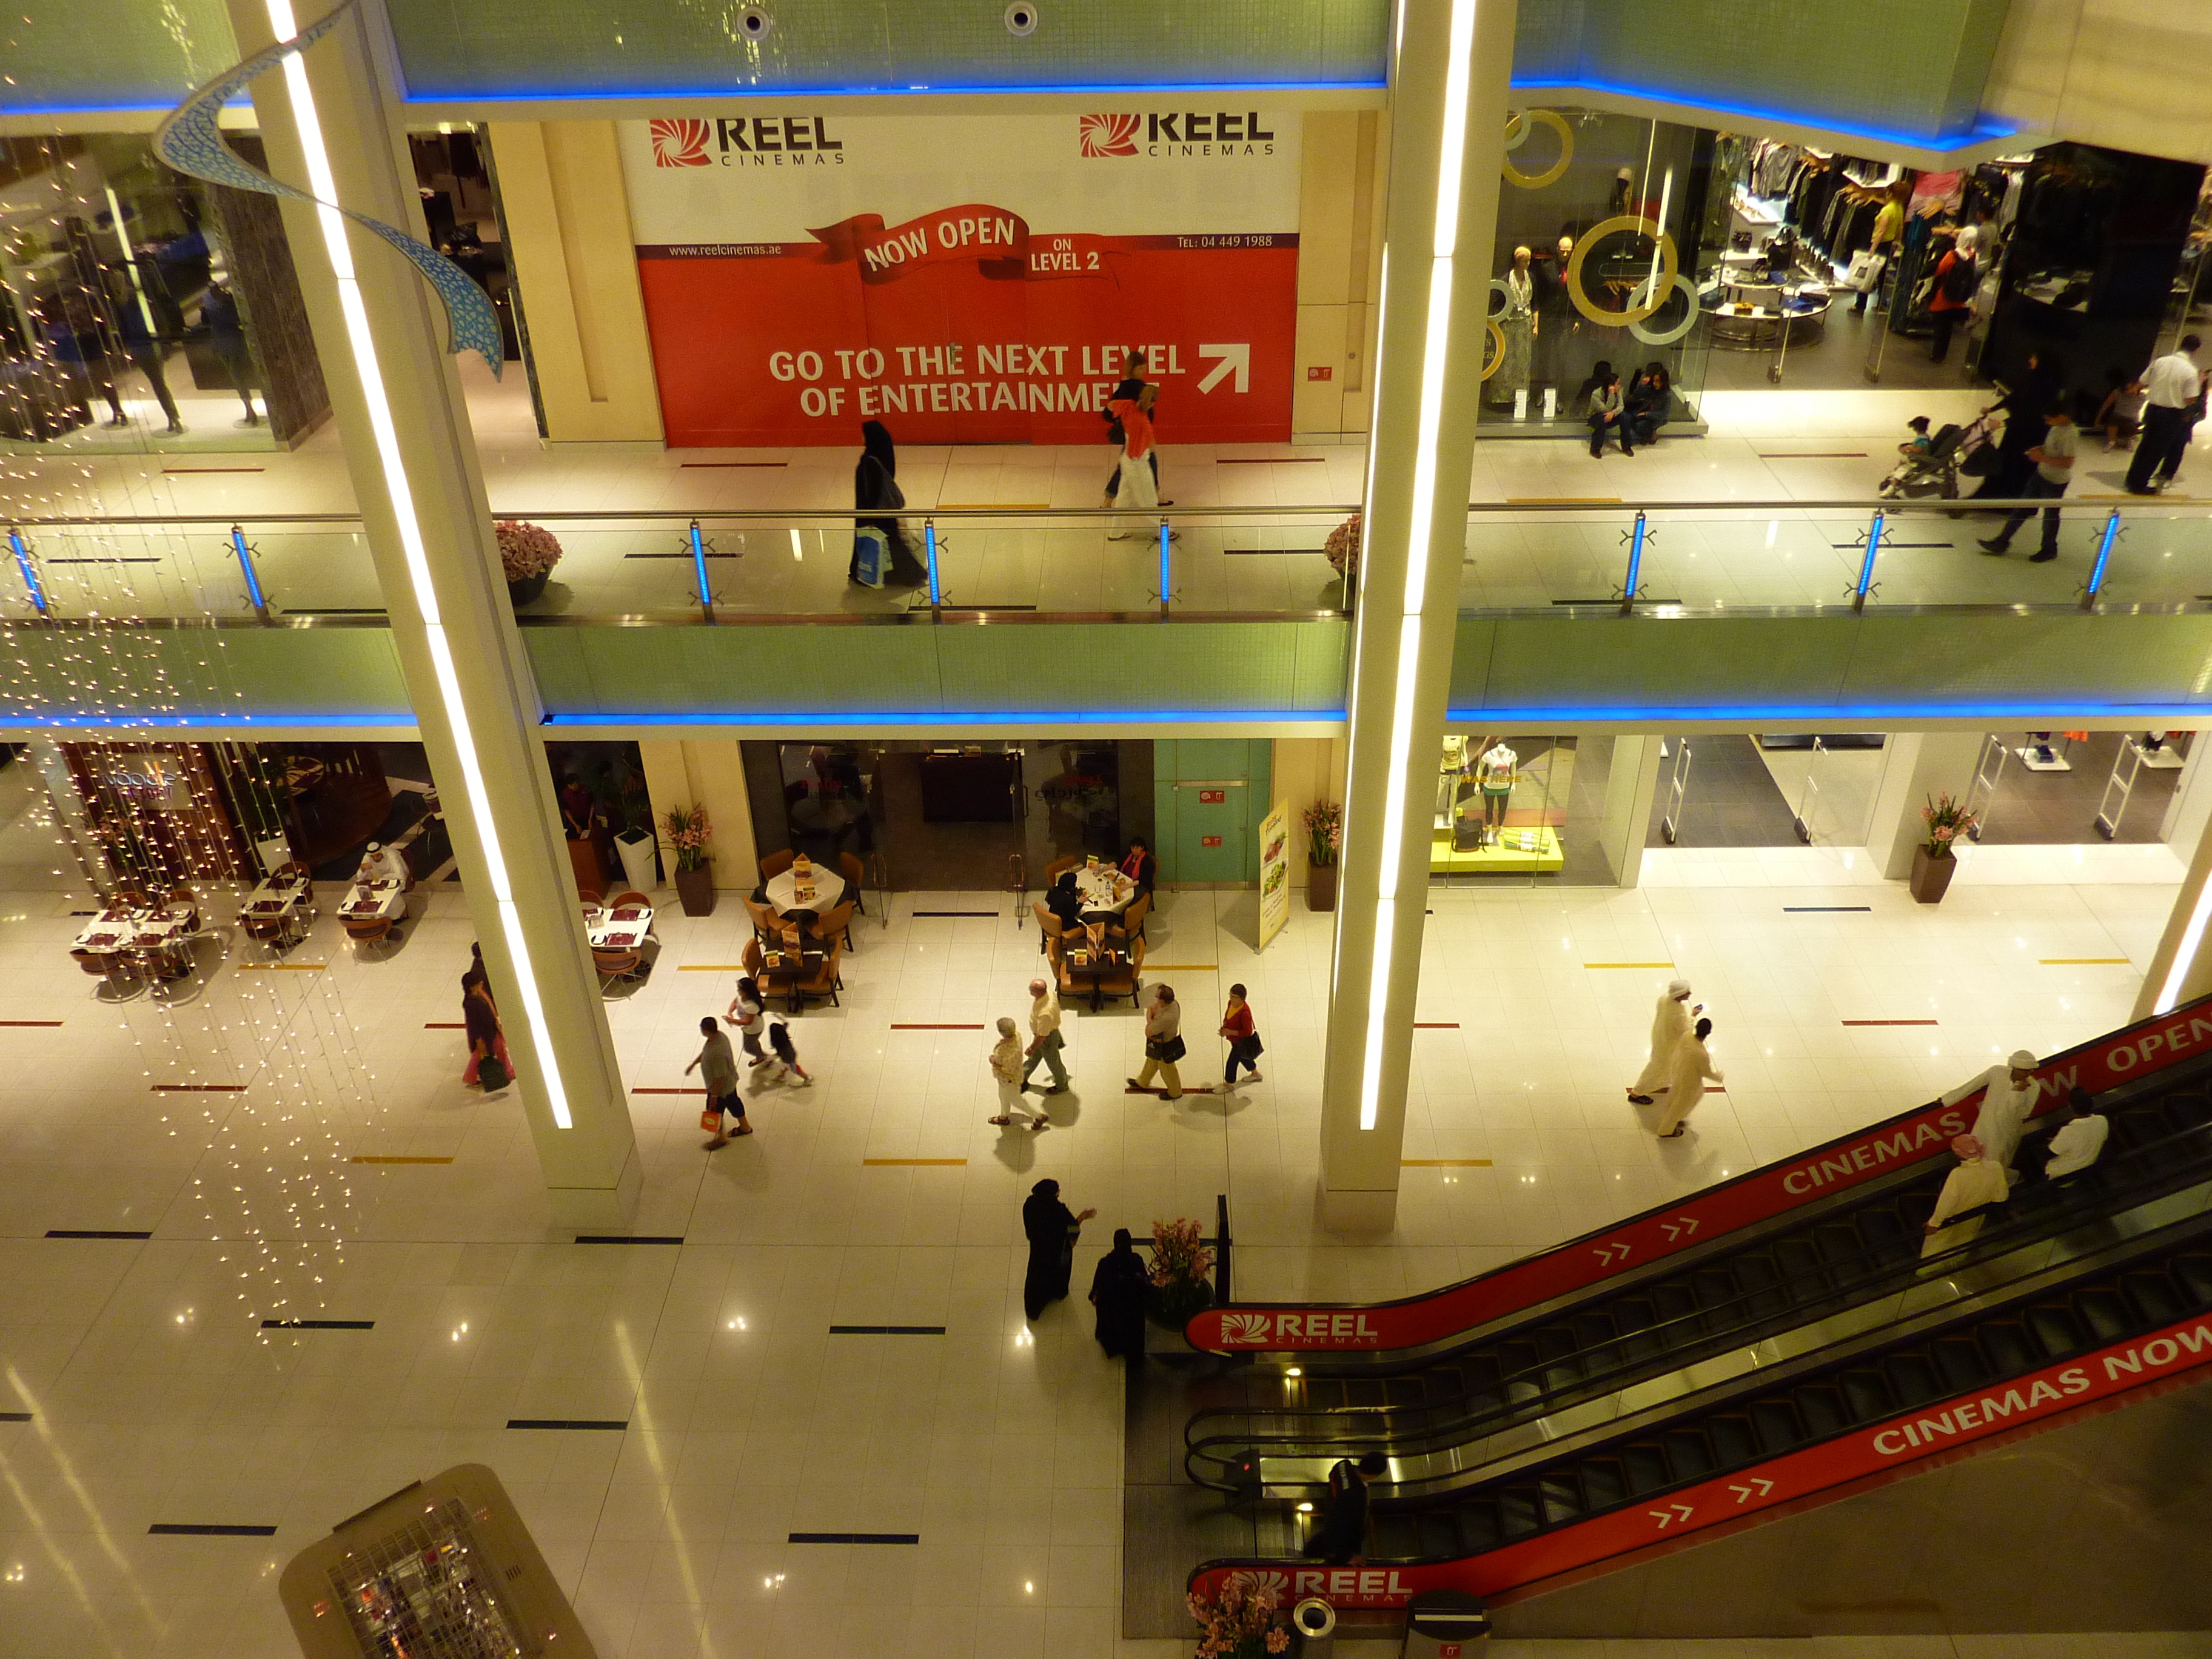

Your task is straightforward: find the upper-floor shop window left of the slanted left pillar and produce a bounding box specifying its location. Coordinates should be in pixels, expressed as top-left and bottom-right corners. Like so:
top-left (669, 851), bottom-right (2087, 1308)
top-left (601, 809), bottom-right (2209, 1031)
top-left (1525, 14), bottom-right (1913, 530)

top-left (0, 133), bottom-right (330, 454)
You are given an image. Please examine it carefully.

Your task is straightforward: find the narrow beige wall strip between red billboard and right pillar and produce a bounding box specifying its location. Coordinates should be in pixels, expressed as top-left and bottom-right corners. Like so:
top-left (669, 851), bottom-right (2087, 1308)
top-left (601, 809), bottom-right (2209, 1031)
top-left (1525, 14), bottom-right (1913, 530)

top-left (1290, 110), bottom-right (1387, 436)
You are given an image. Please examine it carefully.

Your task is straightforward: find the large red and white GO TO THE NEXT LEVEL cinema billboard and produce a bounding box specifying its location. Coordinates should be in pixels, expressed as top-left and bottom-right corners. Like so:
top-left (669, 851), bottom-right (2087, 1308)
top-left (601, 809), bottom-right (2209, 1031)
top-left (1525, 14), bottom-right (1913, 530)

top-left (619, 109), bottom-right (1298, 447)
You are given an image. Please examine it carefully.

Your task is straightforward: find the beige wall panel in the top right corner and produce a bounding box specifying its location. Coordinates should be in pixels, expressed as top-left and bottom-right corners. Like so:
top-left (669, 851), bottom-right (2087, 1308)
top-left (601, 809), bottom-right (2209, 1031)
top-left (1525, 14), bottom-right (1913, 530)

top-left (1982, 0), bottom-right (2212, 161)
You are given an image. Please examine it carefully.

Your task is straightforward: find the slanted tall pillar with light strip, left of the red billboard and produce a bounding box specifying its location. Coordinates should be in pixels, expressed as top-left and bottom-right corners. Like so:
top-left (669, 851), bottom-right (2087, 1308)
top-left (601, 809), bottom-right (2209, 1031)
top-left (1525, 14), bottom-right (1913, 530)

top-left (230, 0), bottom-right (639, 1225)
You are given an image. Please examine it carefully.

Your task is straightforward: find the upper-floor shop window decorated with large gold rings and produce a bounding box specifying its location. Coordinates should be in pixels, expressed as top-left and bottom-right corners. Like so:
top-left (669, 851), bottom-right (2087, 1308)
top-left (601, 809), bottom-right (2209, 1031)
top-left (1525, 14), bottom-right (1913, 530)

top-left (1482, 109), bottom-right (1725, 434)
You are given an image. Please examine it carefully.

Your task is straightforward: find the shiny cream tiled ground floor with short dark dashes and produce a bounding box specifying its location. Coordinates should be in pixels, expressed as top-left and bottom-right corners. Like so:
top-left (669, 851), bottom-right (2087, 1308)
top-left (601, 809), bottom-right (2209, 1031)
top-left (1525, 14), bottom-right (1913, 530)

top-left (0, 847), bottom-right (2185, 1659)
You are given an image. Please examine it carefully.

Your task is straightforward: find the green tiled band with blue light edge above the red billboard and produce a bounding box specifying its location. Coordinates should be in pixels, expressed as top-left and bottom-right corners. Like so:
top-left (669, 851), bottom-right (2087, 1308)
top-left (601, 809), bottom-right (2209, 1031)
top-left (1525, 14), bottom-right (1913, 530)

top-left (387, 0), bottom-right (1389, 98)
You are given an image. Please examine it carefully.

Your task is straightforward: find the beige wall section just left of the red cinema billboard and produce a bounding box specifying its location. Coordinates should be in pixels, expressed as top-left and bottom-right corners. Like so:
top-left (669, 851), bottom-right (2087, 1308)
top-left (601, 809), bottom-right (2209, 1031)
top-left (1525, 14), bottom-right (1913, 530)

top-left (489, 122), bottom-right (662, 443)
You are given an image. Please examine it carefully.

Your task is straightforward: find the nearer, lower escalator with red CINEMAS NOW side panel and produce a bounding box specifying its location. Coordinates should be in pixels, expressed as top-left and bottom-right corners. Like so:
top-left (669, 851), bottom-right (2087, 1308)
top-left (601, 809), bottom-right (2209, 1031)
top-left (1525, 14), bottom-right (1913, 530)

top-left (1192, 1062), bottom-right (2212, 1608)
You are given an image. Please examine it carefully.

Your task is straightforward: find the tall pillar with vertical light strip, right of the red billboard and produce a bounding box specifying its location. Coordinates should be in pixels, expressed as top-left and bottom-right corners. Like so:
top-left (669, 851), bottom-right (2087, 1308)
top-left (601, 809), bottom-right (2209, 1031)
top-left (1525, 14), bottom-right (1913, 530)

top-left (1321, 0), bottom-right (1515, 1228)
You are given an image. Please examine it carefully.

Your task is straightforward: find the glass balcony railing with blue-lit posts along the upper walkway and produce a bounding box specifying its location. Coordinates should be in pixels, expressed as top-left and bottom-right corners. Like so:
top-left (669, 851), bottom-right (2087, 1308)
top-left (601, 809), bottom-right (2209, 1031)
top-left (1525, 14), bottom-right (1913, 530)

top-left (0, 495), bottom-right (2212, 626)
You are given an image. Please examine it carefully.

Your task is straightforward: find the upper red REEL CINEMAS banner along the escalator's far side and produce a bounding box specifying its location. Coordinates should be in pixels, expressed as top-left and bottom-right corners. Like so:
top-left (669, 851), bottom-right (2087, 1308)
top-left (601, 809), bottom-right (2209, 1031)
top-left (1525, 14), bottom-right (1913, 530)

top-left (1184, 997), bottom-right (2212, 1354)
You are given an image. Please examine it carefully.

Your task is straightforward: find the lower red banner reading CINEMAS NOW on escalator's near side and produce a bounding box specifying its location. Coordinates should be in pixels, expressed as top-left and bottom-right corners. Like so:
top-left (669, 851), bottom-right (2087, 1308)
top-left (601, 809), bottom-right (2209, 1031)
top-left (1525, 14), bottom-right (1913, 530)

top-left (1190, 1318), bottom-right (2212, 1608)
